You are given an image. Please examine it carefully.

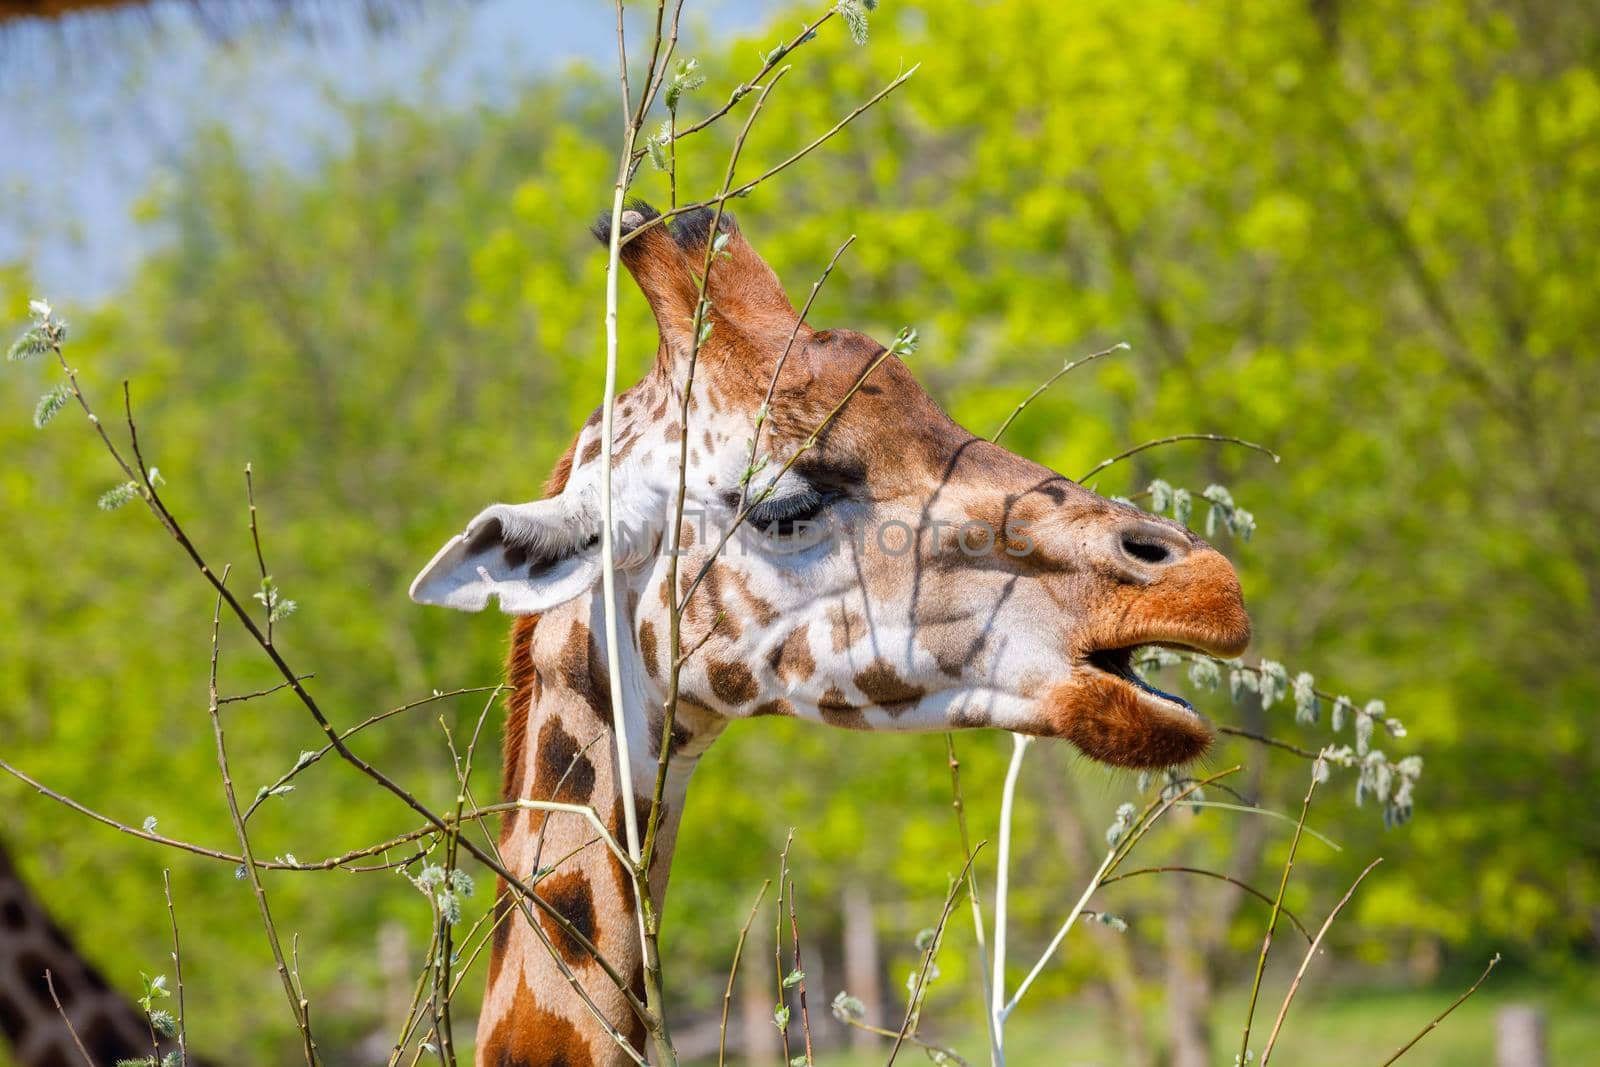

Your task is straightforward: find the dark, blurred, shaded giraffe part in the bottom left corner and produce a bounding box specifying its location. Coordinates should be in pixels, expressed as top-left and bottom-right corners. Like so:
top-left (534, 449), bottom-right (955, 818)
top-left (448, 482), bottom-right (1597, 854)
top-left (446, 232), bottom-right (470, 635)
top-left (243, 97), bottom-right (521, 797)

top-left (0, 845), bottom-right (198, 1067)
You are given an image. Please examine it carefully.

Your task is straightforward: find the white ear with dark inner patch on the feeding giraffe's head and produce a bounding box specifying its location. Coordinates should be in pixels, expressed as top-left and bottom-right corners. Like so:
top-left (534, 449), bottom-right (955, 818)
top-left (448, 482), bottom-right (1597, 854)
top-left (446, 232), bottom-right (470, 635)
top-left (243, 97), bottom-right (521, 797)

top-left (411, 493), bottom-right (600, 614)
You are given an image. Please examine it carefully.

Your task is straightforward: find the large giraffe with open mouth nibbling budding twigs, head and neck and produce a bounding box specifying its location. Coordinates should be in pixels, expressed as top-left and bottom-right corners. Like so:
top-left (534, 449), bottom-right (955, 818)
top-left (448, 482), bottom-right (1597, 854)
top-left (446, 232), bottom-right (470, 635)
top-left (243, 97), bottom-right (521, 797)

top-left (411, 202), bottom-right (1250, 1067)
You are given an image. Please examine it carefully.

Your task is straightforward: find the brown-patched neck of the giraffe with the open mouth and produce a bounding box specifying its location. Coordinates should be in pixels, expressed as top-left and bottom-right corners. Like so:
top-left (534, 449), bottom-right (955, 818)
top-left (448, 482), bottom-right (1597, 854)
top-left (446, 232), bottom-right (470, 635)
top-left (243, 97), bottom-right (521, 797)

top-left (477, 593), bottom-right (709, 1067)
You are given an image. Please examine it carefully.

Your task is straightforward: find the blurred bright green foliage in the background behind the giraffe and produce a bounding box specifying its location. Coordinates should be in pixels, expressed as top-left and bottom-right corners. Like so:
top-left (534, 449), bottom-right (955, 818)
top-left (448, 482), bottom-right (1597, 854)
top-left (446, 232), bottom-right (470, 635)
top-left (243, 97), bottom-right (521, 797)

top-left (0, 0), bottom-right (1600, 1062)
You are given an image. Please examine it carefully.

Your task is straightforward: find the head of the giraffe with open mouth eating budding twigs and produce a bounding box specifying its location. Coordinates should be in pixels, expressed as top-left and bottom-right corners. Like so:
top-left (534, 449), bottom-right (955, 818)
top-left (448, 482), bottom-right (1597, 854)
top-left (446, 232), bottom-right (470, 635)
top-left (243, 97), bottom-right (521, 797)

top-left (411, 203), bottom-right (1250, 768)
